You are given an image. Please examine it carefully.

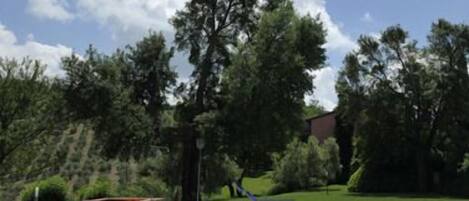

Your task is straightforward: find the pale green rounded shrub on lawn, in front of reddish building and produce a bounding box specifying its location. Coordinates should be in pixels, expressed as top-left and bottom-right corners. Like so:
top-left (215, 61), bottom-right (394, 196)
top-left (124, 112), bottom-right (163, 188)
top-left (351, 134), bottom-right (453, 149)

top-left (271, 136), bottom-right (340, 193)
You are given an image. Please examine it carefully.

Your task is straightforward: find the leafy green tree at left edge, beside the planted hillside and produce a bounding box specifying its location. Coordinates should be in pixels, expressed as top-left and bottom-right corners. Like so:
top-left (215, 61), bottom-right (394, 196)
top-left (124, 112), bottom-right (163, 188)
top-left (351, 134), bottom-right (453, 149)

top-left (0, 58), bottom-right (63, 176)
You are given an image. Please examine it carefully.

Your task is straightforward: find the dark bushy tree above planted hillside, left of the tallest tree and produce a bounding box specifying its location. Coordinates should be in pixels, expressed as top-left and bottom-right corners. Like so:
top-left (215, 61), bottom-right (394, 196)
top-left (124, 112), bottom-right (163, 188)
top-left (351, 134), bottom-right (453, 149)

top-left (63, 32), bottom-right (176, 158)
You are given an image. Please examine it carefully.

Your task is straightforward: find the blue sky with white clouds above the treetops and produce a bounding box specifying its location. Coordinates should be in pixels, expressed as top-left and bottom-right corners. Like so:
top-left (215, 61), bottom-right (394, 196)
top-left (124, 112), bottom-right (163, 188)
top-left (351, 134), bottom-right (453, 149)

top-left (0, 0), bottom-right (469, 110)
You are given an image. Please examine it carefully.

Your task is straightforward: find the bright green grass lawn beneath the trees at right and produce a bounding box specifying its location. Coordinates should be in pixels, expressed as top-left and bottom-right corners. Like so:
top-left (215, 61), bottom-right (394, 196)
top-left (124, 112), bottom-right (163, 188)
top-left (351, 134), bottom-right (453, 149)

top-left (209, 173), bottom-right (468, 201)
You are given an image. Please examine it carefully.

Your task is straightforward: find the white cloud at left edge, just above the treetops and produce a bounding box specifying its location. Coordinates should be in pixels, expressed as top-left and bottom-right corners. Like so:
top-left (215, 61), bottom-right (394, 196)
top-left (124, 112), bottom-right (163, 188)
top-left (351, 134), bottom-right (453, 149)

top-left (0, 23), bottom-right (72, 76)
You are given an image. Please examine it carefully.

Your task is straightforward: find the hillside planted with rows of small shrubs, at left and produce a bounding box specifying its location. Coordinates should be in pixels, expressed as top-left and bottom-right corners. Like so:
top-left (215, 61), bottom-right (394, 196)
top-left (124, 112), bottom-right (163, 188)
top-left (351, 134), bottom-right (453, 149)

top-left (0, 124), bottom-right (138, 200)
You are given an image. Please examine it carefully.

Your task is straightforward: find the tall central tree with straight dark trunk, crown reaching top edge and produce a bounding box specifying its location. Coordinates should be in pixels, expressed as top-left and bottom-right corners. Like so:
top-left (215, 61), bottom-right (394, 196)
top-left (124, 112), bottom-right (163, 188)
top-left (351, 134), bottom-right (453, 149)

top-left (171, 0), bottom-right (257, 201)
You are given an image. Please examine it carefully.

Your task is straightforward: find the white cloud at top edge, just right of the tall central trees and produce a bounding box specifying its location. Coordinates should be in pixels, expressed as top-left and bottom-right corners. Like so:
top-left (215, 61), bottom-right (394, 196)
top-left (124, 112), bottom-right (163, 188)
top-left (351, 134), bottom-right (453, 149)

top-left (294, 0), bottom-right (357, 53)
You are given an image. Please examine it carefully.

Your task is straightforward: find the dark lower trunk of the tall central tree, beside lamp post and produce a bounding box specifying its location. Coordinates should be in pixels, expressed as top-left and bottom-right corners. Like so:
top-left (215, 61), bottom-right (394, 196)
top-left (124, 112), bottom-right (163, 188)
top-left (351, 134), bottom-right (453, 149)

top-left (181, 126), bottom-right (198, 201)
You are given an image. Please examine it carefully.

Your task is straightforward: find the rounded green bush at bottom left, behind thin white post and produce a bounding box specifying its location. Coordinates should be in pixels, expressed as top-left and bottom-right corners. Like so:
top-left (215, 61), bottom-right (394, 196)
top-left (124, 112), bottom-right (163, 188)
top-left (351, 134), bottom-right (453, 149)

top-left (20, 176), bottom-right (67, 201)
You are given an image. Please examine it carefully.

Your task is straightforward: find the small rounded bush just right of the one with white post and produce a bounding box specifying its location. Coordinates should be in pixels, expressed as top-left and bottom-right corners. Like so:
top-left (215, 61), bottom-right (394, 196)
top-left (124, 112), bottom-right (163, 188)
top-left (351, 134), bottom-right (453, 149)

top-left (78, 177), bottom-right (114, 200)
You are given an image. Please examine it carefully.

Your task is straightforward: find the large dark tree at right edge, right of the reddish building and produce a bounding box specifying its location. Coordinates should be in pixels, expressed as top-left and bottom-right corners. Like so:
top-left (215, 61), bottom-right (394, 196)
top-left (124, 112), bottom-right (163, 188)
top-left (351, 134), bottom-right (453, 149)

top-left (337, 20), bottom-right (469, 192)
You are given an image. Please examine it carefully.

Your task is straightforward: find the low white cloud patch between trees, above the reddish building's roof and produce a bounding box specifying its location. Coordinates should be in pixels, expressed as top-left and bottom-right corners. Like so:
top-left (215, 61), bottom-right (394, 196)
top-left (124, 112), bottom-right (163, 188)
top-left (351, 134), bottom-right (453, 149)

top-left (306, 66), bottom-right (337, 111)
